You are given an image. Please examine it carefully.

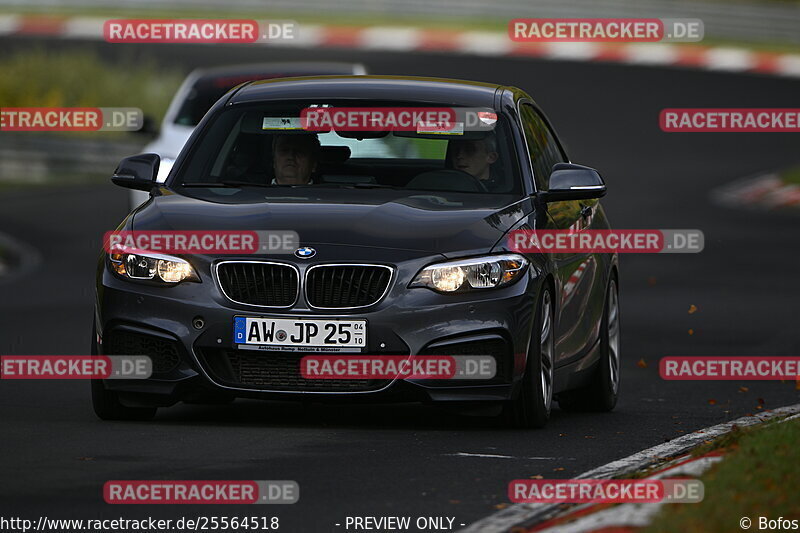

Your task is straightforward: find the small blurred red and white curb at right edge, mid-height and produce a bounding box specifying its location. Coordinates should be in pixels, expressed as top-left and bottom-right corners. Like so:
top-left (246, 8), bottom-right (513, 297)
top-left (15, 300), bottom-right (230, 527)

top-left (711, 173), bottom-right (800, 210)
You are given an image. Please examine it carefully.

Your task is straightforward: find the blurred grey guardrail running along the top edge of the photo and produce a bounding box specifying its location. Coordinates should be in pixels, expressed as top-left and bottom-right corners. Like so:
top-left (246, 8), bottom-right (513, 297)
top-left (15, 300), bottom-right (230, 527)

top-left (0, 0), bottom-right (800, 43)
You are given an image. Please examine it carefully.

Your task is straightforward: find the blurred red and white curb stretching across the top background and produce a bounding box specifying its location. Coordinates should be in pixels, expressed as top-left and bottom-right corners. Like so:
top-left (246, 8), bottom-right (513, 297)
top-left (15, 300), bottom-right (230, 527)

top-left (0, 15), bottom-right (800, 77)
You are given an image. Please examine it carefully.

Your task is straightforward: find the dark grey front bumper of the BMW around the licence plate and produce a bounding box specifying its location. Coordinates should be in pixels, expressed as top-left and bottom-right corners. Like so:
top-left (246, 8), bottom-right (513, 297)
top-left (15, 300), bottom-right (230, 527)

top-left (95, 254), bottom-right (539, 406)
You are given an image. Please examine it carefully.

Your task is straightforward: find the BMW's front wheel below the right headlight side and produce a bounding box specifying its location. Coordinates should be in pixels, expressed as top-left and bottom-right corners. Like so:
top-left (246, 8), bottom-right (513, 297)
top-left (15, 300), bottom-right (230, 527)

top-left (503, 286), bottom-right (555, 428)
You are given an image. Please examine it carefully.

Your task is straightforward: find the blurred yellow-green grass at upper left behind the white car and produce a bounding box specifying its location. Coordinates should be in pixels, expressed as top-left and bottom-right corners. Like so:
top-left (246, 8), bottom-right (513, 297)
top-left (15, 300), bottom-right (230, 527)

top-left (0, 48), bottom-right (184, 130)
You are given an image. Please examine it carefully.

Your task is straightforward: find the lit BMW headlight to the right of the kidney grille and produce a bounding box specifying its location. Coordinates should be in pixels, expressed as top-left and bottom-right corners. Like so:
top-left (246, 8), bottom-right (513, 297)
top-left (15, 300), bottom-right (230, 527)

top-left (409, 254), bottom-right (528, 292)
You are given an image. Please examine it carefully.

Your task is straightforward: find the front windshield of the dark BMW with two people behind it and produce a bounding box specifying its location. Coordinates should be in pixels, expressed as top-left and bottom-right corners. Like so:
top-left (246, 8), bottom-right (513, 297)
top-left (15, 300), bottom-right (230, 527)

top-left (172, 101), bottom-right (522, 194)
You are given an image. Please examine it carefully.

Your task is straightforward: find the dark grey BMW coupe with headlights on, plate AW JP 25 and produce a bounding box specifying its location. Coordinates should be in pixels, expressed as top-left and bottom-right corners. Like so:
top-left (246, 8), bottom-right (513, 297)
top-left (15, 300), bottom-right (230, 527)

top-left (92, 76), bottom-right (620, 427)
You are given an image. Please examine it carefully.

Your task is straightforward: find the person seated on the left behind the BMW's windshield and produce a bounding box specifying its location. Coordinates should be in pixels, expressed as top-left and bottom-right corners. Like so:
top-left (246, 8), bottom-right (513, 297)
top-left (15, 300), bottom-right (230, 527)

top-left (272, 134), bottom-right (320, 185)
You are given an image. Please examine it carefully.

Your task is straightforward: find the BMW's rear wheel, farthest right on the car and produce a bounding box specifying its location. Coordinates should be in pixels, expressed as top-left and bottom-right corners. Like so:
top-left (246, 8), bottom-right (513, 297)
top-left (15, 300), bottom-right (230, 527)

top-left (558, 276), bottom-right (621, 412)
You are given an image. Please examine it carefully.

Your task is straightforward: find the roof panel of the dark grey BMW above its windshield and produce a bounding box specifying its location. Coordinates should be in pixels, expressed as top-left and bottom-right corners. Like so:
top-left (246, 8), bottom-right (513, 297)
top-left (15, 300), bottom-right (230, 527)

top-left (229, 76), bottom-right (501, 108)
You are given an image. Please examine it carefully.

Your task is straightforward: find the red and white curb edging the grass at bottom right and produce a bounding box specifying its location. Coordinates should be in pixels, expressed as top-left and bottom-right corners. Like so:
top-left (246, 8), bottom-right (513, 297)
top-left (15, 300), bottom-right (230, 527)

top-left (459, 404), bottom-right (800, 533)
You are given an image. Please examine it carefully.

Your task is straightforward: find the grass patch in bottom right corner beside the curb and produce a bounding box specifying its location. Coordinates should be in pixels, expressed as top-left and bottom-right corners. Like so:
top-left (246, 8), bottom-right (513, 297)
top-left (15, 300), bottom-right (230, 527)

top-left (644, 420), bottom-right (800, 533)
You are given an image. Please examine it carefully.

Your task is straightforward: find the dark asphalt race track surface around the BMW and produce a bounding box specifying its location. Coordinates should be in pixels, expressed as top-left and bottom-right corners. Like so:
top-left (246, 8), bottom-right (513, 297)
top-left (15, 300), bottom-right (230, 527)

top-left (0, 39), bottom-right (800, 531)
